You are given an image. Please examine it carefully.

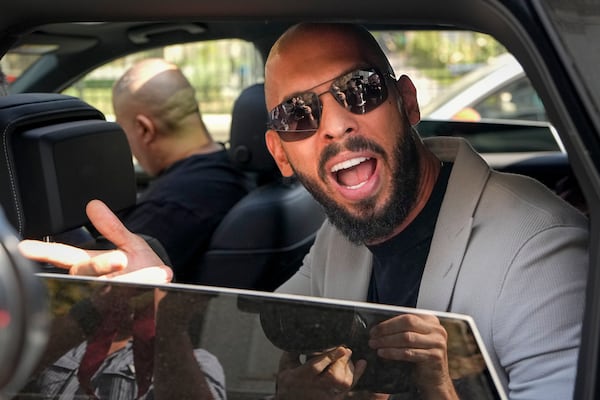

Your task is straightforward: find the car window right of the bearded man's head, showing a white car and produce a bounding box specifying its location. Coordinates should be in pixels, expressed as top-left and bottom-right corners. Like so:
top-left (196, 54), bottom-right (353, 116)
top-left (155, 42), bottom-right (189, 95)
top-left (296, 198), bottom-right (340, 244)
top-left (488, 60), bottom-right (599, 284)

top-left (374, 31), bottom-right (562, 153)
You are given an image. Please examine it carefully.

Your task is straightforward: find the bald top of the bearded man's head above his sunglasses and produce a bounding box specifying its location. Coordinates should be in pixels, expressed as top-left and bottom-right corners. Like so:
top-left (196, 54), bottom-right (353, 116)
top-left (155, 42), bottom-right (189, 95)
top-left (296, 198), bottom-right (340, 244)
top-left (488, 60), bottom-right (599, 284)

top-left (265, 23), bottom-right (393, 109)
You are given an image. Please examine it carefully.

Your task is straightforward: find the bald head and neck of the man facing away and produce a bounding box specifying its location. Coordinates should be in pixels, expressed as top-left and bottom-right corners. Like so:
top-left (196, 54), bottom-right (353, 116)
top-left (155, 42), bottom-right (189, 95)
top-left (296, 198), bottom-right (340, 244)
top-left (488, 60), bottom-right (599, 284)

top-left (113, 58), bottom-right (220, 175)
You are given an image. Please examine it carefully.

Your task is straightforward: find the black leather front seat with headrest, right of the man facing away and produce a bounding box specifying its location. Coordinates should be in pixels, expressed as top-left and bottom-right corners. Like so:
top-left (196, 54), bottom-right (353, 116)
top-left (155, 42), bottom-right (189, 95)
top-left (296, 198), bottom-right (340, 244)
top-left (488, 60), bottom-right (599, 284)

top-left (196, 84), bottom-right (325, 291)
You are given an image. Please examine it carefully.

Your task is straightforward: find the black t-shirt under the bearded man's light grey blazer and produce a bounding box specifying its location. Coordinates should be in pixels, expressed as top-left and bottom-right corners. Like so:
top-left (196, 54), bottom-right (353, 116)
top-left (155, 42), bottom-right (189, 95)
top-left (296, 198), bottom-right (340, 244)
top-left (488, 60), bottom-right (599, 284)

top-left (367, 163), bottom-right (452, 307)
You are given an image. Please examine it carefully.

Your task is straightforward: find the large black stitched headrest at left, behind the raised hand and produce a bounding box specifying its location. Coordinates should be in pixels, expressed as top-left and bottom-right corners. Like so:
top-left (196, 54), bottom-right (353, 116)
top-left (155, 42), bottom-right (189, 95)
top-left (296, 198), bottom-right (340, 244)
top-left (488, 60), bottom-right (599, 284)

top-left (0, 93), bottom-right (136, 238)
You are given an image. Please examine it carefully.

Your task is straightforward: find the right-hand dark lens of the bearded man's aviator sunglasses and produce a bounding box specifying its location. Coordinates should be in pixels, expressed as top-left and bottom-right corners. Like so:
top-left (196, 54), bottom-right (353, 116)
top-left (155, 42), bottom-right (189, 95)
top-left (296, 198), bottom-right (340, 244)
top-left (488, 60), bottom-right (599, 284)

top-left (330, 69), bottom-right (387, 114)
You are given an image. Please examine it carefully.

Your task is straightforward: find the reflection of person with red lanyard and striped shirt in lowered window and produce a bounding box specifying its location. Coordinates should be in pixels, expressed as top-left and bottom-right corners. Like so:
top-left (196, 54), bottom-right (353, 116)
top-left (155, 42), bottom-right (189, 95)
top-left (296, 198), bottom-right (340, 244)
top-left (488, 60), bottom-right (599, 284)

top-left (19, 279), bottom-right (226, 400)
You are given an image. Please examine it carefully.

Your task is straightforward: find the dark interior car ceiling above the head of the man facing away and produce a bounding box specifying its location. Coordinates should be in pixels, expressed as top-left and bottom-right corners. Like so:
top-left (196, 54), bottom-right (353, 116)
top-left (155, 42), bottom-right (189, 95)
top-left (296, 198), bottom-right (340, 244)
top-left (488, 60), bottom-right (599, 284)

top-left (6, 21), bottom-right (288, 93)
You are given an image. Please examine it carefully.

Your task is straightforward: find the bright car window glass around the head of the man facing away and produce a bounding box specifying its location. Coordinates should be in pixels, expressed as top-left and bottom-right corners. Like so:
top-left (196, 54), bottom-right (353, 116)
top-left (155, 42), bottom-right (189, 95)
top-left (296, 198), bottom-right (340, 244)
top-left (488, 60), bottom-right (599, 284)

top-left (63, 39), bottom-right (264, 142)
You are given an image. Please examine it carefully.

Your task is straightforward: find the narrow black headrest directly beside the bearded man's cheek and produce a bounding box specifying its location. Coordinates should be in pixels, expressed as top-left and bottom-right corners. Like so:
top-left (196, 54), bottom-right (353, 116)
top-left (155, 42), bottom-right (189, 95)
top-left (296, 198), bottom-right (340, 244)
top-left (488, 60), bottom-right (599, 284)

top-left (230, 83), bottom-right (280, 180)
